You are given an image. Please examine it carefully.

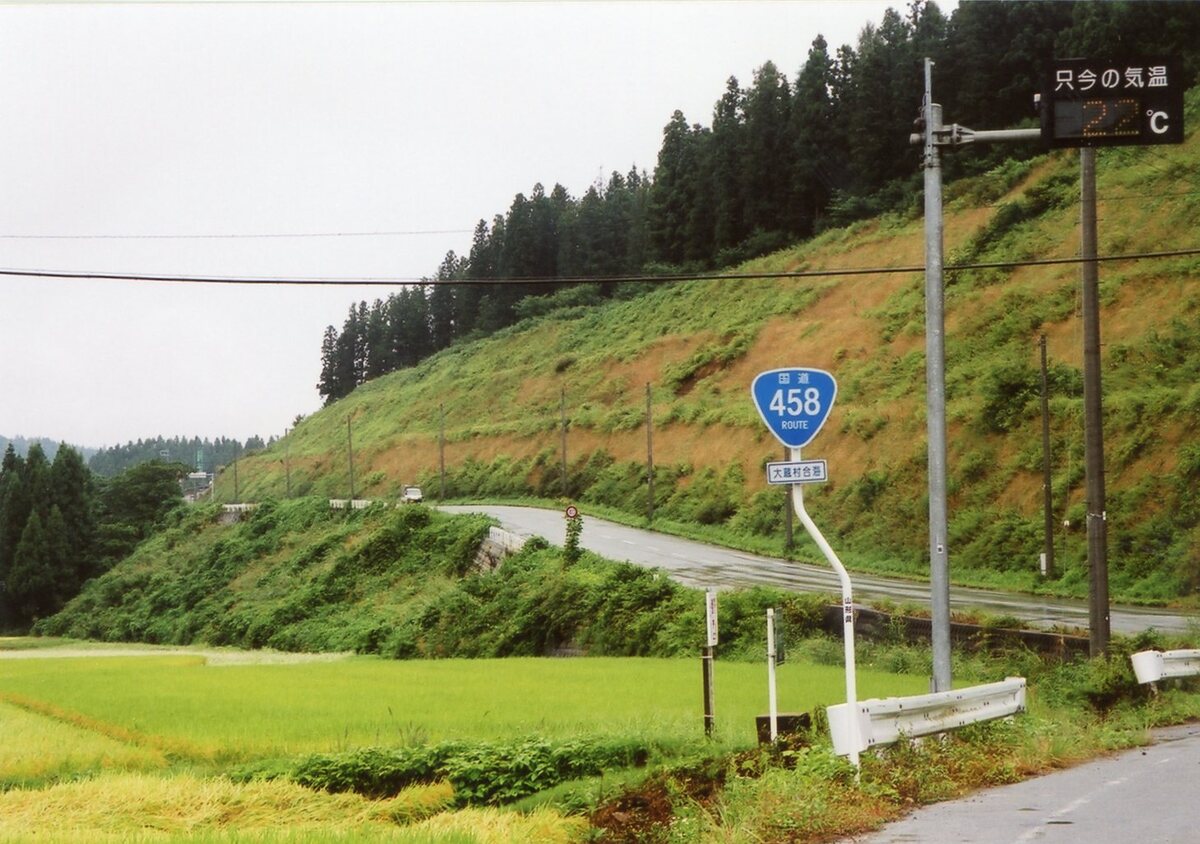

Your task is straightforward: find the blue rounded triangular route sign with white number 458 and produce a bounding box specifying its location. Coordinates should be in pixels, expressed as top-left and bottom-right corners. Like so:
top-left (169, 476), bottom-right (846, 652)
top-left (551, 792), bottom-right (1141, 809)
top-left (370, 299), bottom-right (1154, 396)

top-left (750, 367), bottom-right (838, 448)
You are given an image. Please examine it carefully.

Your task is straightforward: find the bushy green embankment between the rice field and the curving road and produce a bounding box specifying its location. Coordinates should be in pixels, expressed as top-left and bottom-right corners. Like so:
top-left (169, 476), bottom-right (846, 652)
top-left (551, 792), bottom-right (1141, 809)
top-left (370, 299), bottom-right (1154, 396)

top-left (36, 499), bottom-right (823, 658)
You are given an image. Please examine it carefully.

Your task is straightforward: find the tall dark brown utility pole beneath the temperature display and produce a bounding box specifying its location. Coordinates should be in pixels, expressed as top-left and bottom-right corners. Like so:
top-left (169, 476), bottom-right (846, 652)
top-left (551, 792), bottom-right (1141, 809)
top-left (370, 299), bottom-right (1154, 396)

top-left (1079, 148), bottom-right (1109, 657)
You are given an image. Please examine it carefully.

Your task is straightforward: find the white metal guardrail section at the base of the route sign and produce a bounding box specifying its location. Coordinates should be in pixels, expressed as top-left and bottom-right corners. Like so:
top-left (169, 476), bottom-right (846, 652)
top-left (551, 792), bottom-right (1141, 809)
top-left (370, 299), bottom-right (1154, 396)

top-left (826, 677), bottom-right (1025, 756)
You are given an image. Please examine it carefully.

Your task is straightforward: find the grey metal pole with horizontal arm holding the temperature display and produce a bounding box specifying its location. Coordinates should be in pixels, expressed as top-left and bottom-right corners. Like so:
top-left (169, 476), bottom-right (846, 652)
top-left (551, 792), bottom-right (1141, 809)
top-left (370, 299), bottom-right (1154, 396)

top-left (910, 59), bottom-right (1042, 692)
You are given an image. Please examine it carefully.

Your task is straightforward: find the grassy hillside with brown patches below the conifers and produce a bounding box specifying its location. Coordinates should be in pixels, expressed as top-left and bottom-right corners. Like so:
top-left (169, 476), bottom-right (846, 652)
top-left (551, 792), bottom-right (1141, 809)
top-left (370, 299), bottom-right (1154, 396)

top-left (229, 94), bottom-right (1200, 600)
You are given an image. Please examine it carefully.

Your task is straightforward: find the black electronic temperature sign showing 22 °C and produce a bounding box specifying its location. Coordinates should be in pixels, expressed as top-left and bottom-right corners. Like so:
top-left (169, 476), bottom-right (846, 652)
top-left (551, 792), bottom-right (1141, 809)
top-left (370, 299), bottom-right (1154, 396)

top-left (1042, 58), bottom-right (1183, 146)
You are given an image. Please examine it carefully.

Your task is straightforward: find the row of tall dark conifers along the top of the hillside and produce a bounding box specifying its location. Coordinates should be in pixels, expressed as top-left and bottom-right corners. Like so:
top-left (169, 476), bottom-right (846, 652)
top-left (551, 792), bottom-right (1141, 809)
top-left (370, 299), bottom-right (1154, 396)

top-left (317, 0), bottom-right (1200, 403)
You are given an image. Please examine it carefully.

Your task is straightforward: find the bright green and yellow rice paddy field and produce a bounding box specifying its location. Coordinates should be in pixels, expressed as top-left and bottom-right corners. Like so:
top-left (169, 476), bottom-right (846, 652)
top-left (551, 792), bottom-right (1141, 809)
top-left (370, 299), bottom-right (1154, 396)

top-left (0, 642), bottom-right (925, 842)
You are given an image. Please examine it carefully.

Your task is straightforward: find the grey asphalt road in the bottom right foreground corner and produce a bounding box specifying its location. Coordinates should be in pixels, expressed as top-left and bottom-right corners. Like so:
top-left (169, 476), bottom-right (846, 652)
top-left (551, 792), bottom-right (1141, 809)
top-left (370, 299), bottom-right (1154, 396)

top-left (846, 724), bottom-right (1200, 844)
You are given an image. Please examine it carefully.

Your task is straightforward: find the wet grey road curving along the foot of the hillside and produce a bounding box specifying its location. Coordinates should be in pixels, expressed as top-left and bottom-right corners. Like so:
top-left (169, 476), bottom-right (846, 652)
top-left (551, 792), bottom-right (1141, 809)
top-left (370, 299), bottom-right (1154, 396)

top-left (442, 504), bottom-right (1195, 633)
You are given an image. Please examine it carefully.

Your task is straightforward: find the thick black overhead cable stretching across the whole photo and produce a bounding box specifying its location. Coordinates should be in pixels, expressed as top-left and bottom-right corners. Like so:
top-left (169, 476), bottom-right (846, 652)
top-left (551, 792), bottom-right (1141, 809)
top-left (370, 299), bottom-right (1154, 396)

top-left (0, 247), bottom-right (1200, 287)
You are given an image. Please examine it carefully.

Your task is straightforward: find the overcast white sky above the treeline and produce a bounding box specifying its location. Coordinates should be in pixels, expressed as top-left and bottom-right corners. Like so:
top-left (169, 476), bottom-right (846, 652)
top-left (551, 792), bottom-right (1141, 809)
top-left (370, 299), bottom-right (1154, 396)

top-left (0, 0), bottom-right (916, 447)
